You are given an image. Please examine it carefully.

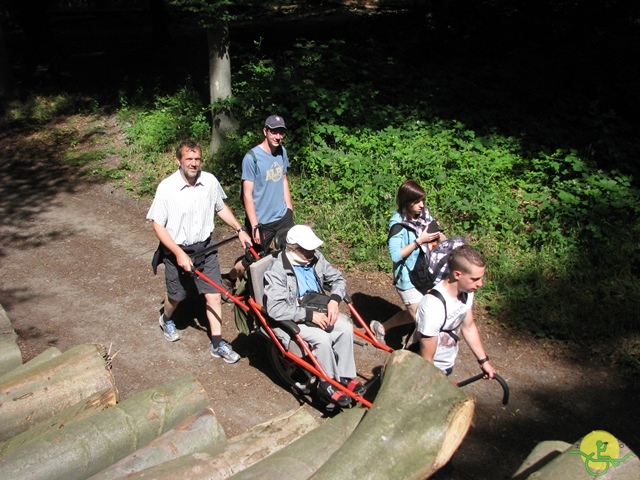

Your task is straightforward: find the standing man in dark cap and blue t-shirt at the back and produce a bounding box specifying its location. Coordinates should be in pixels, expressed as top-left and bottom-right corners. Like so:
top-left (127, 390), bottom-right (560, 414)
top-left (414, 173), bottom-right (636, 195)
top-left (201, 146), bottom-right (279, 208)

top-left (223, 115), bottom-right (293, 287)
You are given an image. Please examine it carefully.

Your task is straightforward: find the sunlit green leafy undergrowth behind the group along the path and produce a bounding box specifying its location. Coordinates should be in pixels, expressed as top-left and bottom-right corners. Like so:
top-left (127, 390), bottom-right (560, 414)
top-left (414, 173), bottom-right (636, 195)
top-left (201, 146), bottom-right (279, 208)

top-left (111, 29), bottom-right (640, 352)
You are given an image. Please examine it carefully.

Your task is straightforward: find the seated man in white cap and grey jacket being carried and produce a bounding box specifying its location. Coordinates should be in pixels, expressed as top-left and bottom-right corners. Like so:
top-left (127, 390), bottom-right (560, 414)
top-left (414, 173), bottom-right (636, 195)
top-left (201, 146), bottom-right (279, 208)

top-left (264, 225), bottom-right (364, 407)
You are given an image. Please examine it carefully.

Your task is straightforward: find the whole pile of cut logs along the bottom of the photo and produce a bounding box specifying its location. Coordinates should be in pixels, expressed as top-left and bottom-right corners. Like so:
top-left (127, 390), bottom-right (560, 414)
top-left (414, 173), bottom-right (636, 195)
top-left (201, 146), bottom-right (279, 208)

top-left (11, 300), bottom-right (640, 480)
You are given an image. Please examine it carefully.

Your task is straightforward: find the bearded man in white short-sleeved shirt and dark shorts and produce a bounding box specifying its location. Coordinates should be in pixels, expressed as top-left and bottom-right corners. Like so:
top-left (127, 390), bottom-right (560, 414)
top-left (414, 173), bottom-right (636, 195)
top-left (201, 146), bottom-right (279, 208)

top-left (147, 141), bottom-right (251, 363)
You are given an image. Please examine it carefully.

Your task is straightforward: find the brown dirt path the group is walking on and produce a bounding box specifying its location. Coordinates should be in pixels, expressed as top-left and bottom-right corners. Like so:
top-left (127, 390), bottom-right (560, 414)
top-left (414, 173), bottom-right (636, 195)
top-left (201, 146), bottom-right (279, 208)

top-left (0, 122), bottom-right (640, 479)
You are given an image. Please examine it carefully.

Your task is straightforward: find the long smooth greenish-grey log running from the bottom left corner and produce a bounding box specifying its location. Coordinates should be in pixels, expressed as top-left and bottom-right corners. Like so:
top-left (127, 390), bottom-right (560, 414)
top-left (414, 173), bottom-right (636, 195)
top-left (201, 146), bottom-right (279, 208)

top-left (0, 375), bottom-right (210, 480)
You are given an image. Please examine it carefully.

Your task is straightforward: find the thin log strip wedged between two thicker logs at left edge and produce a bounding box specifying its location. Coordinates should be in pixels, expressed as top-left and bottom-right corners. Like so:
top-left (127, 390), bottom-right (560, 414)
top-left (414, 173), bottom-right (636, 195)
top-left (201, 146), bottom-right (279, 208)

top-left (0, 388), bottom-right (116, 457)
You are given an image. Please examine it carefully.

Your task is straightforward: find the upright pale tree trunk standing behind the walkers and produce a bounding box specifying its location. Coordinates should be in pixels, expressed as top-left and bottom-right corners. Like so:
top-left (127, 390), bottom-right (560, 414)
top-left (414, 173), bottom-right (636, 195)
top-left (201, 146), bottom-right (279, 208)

top-left (207, 23), bottom-right (238, 155)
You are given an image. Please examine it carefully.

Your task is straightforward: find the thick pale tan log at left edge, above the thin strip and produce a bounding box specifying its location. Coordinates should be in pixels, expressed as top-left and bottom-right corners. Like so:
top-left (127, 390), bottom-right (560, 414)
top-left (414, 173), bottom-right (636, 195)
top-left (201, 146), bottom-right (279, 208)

top-left (0, 345), bottom-right (117, 441)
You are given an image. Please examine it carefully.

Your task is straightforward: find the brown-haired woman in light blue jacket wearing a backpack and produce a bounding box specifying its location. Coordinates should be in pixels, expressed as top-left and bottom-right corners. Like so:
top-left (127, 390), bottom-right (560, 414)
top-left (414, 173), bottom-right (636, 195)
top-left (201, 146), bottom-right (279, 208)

top-left (371, 180), bottom-right (444, 342)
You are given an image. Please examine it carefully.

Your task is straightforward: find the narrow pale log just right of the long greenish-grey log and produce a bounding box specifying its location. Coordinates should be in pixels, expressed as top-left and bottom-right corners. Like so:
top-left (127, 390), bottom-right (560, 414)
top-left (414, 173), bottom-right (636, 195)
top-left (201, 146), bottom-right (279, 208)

top-left (89, 408), bottom-right (226, 480)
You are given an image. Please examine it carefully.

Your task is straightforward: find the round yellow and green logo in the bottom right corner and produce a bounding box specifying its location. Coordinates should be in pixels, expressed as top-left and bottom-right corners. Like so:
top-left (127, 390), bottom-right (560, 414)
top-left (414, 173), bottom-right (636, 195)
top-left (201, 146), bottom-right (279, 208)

top-left (569, 430), bottom-right (636, 477)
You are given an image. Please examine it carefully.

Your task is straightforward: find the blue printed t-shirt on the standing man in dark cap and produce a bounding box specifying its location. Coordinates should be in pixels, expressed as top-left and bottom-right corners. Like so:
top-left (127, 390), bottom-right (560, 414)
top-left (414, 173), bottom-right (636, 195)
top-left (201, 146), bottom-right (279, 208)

top-left (242, 145), bottom-right (289, 224)
